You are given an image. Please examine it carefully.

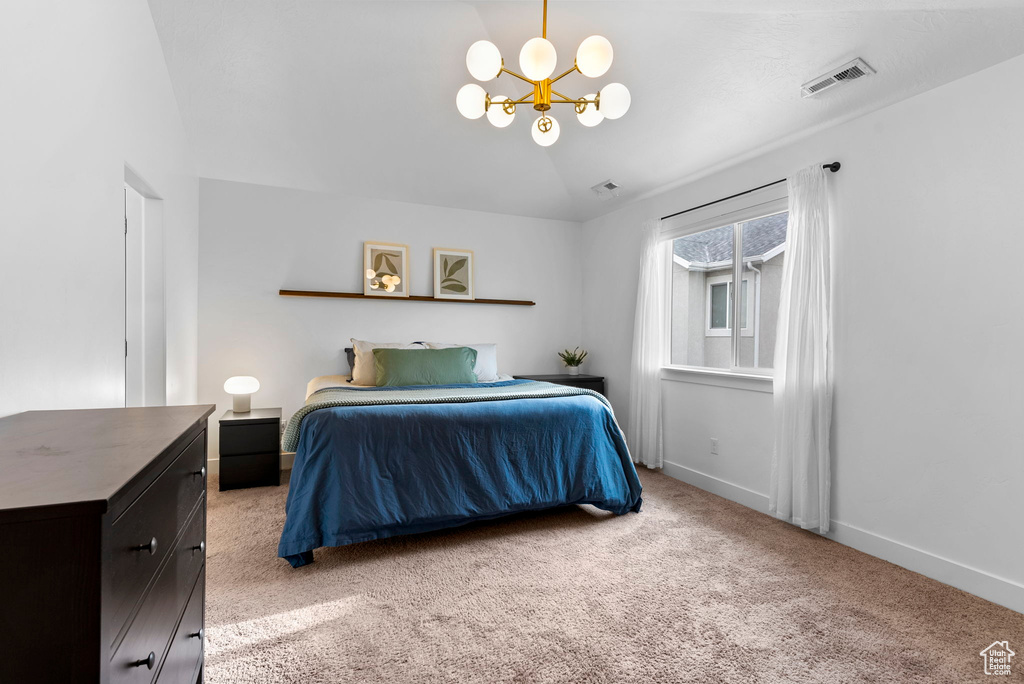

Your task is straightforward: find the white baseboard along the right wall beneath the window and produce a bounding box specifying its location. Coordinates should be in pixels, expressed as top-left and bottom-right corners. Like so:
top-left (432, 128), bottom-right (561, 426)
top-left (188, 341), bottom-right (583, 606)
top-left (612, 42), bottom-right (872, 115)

top-left (663, 462), bottom-right (1024, 612)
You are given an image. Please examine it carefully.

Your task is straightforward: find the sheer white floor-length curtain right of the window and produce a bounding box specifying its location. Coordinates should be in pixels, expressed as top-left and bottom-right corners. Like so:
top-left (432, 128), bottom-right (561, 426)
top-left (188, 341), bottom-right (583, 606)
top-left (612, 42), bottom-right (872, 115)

top-left (768, 165), bottom-right (833, 532)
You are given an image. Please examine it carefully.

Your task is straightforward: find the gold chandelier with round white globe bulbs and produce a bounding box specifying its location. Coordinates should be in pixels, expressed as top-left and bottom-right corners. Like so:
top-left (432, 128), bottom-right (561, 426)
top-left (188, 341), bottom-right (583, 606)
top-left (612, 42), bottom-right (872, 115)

top-left (455, 0), bottom-right (630, 147)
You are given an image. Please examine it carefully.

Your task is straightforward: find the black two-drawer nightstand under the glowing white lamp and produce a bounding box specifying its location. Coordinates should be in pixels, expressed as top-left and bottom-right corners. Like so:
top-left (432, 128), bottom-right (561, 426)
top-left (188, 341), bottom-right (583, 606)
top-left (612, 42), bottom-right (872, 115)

top-left (220, 409), bottom-right (281, 491)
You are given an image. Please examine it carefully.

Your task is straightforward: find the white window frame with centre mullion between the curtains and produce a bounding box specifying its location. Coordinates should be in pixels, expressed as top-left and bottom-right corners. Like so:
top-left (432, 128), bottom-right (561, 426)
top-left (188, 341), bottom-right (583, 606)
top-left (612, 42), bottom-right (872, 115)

top-left (660, 183), bottom-right (790, 381)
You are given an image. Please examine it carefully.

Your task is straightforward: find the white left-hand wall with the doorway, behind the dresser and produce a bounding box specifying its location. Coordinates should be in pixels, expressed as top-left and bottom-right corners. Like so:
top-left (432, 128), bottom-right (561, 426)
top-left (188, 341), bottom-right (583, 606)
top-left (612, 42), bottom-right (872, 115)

top-left (0, 0), bottom-right (198, 416)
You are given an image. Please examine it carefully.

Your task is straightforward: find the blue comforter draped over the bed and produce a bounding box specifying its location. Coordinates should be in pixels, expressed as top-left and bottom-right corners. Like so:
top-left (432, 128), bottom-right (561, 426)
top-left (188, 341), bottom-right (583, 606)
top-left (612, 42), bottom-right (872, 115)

top-left (278, 381), bottom-right (641, 567)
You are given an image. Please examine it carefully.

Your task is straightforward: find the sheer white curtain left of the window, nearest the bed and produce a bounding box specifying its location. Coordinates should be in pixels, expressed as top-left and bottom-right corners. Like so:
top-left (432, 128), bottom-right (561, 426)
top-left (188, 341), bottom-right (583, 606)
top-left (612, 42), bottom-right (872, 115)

top-left (626, 219), bottom-right (671, 468)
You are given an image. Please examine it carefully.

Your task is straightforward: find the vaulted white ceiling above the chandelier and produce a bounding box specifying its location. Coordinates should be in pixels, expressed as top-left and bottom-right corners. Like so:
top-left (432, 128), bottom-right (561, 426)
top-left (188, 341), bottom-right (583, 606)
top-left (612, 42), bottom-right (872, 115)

top-left (150, 0), bottom-right (1024, 220)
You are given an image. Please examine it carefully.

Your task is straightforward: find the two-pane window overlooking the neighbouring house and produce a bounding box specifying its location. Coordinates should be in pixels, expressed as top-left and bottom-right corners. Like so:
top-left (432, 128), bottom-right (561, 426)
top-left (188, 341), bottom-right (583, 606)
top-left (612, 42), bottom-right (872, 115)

top-left (670, 206), bottom-right (788, 371)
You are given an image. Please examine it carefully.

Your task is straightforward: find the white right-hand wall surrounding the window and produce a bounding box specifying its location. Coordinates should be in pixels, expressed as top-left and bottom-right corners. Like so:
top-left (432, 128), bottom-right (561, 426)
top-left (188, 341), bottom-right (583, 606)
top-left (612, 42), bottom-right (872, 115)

top-left (584, 52), bottom-right (1024, 610)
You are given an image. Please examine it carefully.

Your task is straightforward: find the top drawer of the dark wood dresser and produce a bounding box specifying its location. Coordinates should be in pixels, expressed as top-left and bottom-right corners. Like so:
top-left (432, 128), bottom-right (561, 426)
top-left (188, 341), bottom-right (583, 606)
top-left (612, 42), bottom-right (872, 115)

top-left (104, 432), bottom-right (206, 646)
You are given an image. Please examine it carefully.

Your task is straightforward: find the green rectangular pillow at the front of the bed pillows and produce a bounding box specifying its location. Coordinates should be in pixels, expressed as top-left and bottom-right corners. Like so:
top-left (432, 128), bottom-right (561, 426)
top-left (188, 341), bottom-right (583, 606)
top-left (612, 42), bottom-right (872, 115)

top-left (374, 347), bottom-right (476, 387)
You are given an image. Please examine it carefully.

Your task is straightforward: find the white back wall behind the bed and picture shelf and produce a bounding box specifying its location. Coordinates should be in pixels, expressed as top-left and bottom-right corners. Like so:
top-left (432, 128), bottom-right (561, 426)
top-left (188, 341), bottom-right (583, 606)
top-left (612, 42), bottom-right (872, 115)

top-left (199, 179), bottom-right (582, 459)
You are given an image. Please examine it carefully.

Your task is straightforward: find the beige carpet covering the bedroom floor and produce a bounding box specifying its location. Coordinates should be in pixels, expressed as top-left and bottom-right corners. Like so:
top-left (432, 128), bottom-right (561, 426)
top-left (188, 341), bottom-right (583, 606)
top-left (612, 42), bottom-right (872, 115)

top-left (206, 470), bottom-right (1024, 684)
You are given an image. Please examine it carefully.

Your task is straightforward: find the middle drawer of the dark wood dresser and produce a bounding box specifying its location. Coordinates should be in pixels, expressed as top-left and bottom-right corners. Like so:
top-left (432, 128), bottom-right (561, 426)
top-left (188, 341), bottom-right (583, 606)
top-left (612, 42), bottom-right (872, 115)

top-left (110, 500), bottom-right (206, 684)
